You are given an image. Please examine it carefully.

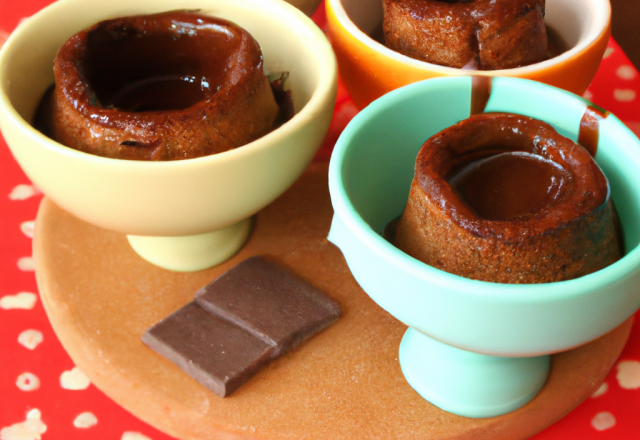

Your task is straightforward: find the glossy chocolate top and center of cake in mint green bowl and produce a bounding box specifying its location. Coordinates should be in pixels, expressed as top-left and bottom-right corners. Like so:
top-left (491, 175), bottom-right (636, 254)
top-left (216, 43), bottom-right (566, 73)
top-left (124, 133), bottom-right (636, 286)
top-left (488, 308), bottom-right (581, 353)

top-left (416, 113), bottom-right (609, 241)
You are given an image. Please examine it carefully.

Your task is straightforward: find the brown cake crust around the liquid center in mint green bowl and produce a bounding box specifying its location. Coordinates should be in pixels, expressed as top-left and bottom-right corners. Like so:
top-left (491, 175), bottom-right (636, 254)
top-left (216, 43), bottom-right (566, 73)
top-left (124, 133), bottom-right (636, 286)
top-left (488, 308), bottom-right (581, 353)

top-left (395, 113), bottom-right (621, 283)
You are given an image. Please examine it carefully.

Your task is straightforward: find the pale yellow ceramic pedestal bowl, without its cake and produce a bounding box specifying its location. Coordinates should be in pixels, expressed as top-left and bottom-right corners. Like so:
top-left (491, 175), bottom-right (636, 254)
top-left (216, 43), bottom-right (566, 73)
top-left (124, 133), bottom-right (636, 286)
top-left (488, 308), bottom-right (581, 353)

top-left (0, 0), bottom-right (337, 270)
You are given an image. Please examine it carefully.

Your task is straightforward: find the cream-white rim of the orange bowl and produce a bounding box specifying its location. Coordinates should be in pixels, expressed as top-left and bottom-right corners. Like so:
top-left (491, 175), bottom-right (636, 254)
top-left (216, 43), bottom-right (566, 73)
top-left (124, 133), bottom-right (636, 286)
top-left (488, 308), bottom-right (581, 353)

top-left (326, 0), bottom-right (611, 76)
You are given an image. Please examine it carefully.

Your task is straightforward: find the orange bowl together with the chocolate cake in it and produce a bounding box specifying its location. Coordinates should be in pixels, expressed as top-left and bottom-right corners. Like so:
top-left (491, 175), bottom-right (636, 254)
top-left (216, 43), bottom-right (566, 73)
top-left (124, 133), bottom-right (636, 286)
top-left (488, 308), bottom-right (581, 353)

top-left (326, 0), bottom-right (611, 108)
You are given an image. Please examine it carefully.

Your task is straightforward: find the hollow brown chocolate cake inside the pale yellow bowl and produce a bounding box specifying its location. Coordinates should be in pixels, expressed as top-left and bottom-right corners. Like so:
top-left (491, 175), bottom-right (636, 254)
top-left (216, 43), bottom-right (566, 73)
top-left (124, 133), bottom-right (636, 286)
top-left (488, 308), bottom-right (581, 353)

top-left (51, 11), bottom-right (279, 160)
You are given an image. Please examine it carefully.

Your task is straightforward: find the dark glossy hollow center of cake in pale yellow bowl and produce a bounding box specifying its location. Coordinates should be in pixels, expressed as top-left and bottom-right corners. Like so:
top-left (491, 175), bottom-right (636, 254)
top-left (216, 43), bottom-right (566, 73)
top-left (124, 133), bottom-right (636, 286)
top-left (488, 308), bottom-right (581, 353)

top-left (81, 20), bottom-right (240, 112)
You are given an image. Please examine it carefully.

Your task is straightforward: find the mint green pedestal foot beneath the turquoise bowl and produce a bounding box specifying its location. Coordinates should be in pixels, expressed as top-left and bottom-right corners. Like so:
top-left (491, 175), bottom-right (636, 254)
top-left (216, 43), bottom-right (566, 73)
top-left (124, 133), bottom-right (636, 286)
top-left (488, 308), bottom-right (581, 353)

top-left (399, 327), bottom-right (550, 418)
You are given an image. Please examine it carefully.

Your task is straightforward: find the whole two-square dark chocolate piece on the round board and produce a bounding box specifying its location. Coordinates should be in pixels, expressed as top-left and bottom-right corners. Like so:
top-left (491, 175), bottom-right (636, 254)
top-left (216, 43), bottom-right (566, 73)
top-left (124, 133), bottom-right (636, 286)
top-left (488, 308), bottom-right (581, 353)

top-left (142, 257), bottom-right (340, 397)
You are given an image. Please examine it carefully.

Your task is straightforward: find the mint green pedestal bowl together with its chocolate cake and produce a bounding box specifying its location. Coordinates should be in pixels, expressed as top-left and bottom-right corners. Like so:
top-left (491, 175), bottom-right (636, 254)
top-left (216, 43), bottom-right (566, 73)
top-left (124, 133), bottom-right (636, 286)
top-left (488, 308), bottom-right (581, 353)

top-left (329, 77), bottom-right (640, 417)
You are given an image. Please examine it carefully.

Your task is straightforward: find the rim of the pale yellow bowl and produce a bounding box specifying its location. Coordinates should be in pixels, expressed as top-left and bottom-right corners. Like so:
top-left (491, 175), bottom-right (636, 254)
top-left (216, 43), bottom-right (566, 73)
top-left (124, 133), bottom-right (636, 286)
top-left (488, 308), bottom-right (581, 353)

top-left (0, 0), bottom-right (337, 171)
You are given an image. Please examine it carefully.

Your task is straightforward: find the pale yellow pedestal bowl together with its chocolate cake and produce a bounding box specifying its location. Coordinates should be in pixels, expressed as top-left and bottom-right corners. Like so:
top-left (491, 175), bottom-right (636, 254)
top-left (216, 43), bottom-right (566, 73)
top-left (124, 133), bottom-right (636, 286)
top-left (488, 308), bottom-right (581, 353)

top-left (0, 0), bottom-right (337, 271)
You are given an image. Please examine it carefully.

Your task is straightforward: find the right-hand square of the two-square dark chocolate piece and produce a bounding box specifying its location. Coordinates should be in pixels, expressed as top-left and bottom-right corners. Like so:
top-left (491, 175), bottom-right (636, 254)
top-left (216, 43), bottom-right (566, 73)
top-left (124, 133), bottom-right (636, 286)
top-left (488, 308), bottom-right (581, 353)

top-left (196, 257), bottom-right (340, 355)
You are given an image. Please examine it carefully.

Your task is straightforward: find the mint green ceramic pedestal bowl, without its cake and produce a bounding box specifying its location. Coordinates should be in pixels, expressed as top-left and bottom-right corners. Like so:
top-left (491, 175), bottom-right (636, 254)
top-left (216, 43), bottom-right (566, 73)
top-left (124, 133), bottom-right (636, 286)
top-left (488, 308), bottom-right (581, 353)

top-left (329, 77), bottom-right (640, 417)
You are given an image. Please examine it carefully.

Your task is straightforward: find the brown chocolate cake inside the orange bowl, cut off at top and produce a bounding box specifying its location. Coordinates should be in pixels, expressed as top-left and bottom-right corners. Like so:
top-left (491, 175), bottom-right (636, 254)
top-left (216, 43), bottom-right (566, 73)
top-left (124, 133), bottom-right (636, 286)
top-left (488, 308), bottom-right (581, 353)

top-left (383, 0), bottom-right (548, 70)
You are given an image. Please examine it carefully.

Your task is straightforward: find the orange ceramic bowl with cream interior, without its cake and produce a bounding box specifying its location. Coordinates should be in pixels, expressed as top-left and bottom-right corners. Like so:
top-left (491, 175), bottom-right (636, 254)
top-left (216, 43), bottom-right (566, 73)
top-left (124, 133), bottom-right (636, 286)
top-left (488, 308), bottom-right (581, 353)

top-left (326, 0), bottom-right (611, 108)
